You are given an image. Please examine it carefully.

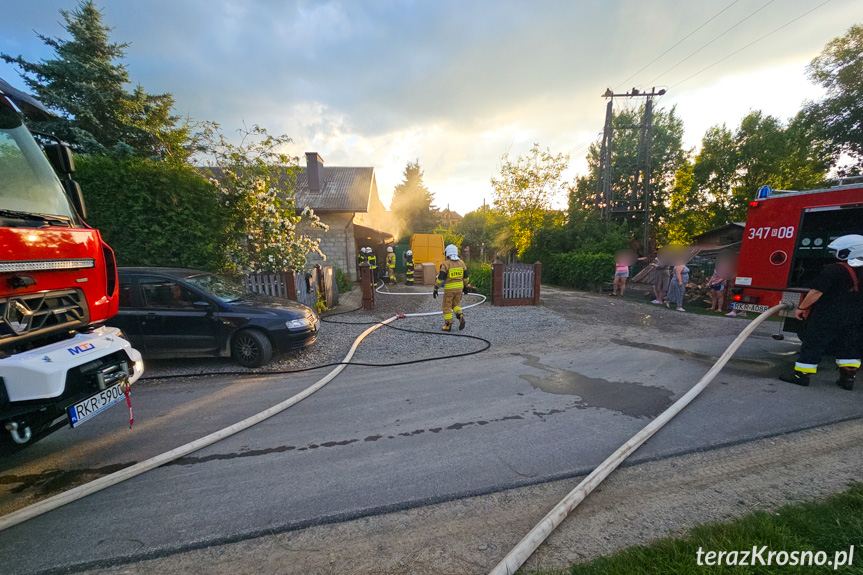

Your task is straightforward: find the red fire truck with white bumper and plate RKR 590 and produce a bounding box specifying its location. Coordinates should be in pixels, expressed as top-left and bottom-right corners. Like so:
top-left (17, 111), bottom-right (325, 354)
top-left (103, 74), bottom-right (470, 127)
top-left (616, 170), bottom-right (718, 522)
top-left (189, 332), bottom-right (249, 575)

top-left (0, 79), bottom-right (144, 448)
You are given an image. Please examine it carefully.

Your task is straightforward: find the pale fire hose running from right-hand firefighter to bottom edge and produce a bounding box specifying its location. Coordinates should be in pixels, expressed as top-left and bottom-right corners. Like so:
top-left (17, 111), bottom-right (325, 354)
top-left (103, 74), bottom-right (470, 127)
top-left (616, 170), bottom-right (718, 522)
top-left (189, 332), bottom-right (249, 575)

top-left (489, 303), bottom-right (791, 575)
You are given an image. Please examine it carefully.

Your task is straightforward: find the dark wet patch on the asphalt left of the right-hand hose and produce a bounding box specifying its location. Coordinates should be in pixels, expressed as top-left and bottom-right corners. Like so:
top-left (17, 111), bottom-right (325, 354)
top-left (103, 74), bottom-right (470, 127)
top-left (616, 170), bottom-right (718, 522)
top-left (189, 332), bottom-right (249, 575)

top-left (516, 354), bottom-right (673, 418)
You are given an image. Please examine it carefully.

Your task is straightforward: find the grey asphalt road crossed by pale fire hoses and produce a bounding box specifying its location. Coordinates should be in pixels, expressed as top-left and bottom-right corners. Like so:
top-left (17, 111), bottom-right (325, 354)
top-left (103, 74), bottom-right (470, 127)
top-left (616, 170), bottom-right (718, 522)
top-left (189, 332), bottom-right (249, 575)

top-left (0, 294), bottom-right (863, 574)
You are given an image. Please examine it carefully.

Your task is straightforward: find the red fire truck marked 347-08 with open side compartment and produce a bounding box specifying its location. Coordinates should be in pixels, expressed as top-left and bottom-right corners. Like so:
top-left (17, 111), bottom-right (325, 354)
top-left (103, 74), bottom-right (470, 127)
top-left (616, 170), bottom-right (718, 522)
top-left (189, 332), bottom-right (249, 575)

top-left (732, 178), bottom-right (863, 333)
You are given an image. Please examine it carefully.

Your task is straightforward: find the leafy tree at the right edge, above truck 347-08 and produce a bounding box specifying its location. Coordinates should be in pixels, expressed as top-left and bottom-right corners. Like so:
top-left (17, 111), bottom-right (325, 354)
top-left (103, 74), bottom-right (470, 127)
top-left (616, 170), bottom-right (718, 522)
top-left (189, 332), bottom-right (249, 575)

top-left (804, 24), bottom-right (863, 175)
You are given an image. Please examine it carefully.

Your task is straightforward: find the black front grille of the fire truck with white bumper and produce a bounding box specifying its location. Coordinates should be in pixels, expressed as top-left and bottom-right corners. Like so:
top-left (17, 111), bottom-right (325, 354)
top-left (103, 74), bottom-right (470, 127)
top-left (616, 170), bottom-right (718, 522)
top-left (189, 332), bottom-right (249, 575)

top-left (0, 289), bottom-right (90, 346)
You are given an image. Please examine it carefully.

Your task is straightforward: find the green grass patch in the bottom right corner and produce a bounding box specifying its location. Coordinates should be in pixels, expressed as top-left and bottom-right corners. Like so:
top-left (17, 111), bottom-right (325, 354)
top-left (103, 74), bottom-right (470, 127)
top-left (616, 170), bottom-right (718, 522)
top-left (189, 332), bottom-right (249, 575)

top-left (552, 485), bottom-right (863, 575)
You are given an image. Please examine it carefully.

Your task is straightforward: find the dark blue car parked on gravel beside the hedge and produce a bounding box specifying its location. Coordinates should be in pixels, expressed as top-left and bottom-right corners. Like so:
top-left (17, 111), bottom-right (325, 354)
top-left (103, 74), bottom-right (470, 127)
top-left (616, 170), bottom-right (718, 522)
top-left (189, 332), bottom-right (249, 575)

top-left (108, 268), bottom-right (320, 367)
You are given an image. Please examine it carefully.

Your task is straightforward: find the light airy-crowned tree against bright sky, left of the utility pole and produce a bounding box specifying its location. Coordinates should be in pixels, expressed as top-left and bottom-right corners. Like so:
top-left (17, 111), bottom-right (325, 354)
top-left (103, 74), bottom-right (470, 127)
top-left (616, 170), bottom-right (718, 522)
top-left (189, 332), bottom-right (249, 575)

top-left (491, 144), bottom-right (569, 254)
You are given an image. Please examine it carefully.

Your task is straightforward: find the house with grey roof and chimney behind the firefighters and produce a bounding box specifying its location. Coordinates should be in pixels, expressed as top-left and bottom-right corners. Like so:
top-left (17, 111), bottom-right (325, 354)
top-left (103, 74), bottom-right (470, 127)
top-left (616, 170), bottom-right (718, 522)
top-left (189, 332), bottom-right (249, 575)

top-left (294, 152), bottom-right (395, 280)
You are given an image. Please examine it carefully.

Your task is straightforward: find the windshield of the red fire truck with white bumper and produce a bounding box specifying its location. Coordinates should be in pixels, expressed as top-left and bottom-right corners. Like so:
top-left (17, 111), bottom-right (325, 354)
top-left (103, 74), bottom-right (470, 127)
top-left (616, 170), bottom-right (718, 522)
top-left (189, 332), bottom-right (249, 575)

top-left (0, 104), bottom-right (78, 225)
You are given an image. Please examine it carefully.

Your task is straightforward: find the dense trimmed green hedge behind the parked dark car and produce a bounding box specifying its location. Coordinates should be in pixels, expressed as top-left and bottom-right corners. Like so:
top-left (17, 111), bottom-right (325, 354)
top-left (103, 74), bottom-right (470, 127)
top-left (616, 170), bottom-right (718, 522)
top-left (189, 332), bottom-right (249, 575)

top-left (75, 156), bottom-right (227, 271)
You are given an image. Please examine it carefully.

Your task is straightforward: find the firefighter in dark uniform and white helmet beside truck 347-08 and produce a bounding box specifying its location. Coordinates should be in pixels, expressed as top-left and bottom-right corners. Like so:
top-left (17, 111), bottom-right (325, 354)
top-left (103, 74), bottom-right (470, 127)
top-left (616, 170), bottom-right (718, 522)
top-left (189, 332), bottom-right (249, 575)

top-left (779, 235), bottom-right (863, 391)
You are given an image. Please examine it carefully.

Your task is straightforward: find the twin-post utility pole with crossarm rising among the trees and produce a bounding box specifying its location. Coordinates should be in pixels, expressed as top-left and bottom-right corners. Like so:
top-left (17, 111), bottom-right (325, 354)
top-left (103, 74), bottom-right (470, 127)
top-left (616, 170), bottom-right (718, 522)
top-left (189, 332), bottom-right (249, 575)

top-left (596, 88), bottom-right (665, 256)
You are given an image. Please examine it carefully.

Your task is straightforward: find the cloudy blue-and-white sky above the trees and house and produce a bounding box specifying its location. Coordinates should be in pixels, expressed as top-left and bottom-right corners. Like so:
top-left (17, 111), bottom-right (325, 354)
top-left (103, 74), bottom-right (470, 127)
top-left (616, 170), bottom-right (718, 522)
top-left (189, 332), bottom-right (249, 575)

top-left (0, 0), bottom-right (863, 213)
